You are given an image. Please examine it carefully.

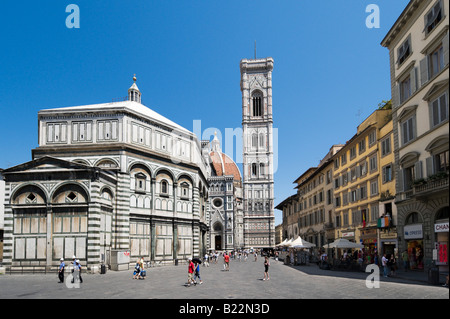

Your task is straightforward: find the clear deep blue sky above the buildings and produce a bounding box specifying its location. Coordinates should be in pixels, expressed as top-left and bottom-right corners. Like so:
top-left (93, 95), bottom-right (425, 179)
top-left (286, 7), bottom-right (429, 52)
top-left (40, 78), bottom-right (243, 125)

top-left (0, 0), bottom-right (408, 224)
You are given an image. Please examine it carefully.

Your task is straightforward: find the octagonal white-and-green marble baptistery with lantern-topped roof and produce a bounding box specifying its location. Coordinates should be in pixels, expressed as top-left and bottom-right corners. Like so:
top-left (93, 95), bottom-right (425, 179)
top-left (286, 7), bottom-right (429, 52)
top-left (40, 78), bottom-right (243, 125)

top-left (2, 78), bottom-right (210, 268)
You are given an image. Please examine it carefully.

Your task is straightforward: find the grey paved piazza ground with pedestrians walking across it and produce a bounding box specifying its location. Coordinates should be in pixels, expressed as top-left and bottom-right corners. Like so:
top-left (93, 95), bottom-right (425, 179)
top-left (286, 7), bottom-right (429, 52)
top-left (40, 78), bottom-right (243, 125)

top-left (0, 258), bottom-right (449, 299)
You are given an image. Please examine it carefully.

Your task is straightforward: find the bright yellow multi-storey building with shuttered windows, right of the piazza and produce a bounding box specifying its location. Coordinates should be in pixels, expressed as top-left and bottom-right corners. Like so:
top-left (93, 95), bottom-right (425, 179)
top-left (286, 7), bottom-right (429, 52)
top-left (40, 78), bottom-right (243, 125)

top-left (333, 108), bottom-right (397, 258)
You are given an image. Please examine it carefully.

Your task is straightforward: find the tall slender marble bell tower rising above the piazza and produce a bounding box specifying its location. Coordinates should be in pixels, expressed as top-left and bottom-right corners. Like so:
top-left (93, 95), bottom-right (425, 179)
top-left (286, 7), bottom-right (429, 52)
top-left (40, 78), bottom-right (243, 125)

top-left (240, 57), bottom-right (275, 248)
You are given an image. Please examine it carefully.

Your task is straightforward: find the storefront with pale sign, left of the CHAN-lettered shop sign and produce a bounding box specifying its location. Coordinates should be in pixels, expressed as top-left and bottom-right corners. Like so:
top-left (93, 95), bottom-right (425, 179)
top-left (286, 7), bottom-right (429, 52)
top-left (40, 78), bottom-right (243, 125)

top-left (403, 224), bottom-right (424, 270)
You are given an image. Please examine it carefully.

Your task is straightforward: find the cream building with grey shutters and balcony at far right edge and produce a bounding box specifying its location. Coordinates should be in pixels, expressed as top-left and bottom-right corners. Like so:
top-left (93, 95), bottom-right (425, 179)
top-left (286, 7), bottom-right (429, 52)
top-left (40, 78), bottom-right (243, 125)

top-left (381, 0), bottom-right (449, 271)
